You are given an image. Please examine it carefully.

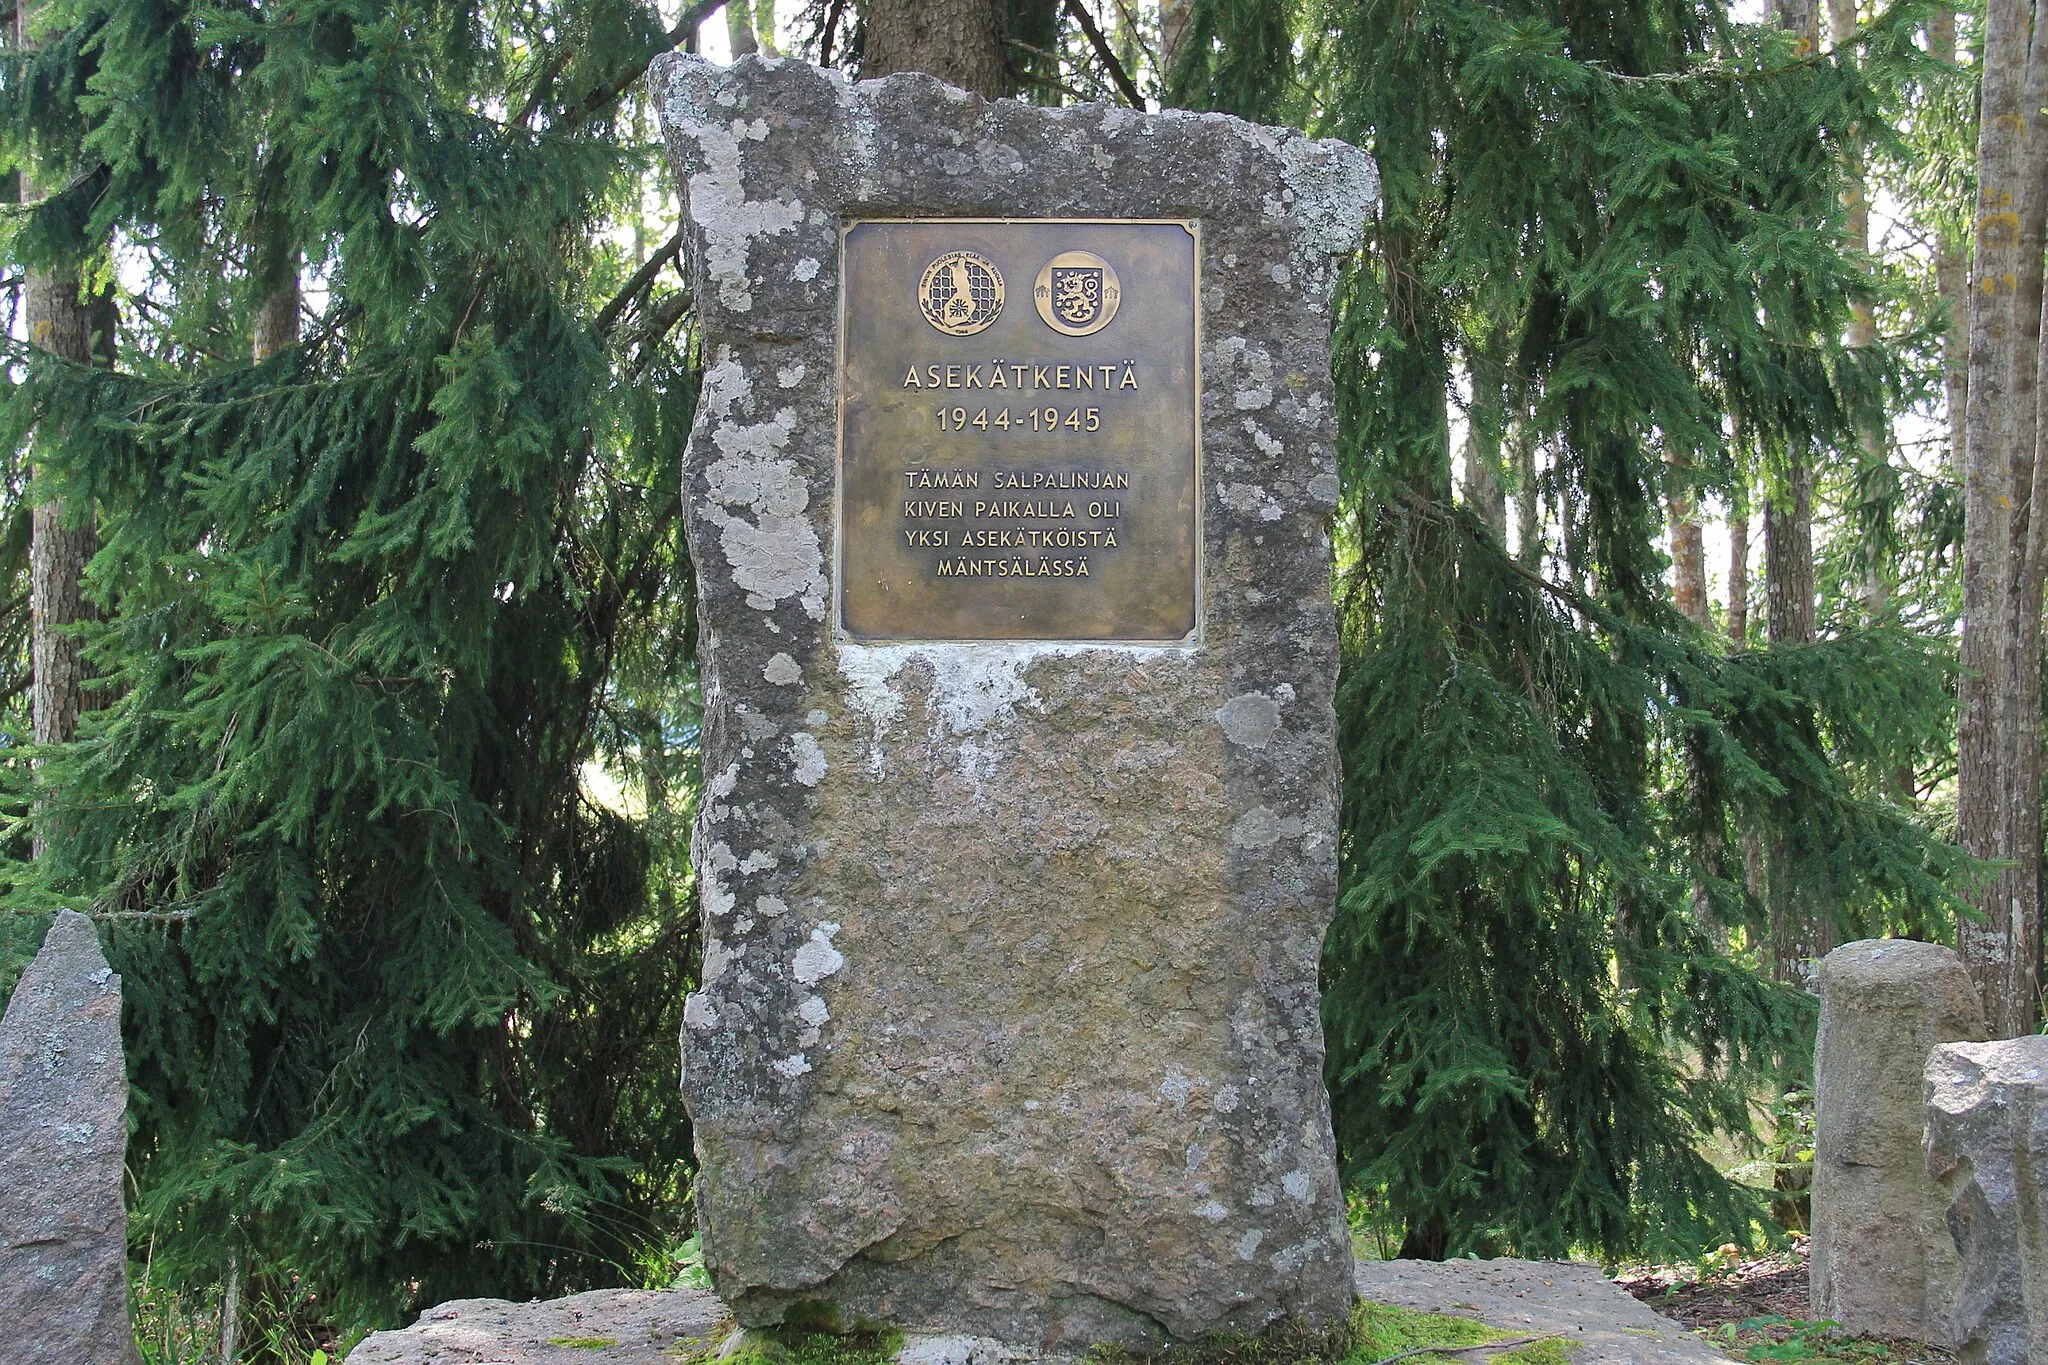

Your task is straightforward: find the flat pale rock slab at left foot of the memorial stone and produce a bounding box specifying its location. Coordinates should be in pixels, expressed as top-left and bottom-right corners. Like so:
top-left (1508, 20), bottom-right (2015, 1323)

top-left (346, 1289), bottom-right (731, 1365)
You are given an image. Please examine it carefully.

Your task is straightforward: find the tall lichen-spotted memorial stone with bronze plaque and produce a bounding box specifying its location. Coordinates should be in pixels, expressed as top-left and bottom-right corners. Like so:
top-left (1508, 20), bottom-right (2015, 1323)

top-left (651, 57), bottom-right (1378, 1351)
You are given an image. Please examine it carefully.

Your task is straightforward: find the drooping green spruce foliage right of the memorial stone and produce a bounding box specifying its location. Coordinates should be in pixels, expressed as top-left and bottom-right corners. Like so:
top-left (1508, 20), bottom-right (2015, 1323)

top-left (1174, 0), bottom-right (1960, 1257)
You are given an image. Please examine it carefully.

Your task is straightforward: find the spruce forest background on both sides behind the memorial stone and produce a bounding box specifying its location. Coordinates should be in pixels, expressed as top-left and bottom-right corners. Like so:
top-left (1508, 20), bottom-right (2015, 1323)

top-left (0, 0), bottom-right (2048, 1361)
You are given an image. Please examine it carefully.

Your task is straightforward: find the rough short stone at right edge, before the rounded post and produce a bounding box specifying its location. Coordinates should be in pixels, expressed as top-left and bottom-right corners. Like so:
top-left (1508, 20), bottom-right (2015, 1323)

top-left (1927, 1033), bottom-right (2048, 1365)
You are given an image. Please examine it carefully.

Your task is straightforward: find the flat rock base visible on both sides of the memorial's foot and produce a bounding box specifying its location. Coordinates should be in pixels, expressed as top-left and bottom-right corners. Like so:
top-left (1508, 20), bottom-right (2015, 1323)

top-left (348, 1261), bottom-right (1744, 1365)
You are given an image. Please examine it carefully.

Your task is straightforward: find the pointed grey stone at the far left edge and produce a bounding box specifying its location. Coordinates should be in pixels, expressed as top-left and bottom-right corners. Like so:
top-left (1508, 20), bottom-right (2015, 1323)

top-left (0, 911), bottom-right (139, 1365)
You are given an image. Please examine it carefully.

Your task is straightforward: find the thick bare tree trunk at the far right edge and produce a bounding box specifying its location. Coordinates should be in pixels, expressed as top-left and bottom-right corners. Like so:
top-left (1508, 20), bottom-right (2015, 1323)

top-left (1956, 0), bottom-right (2048, 1038)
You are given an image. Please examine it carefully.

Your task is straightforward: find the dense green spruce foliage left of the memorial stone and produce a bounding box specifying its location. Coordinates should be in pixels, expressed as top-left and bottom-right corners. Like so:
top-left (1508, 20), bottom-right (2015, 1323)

top-left (4, 0), bottom-right (696, 1324)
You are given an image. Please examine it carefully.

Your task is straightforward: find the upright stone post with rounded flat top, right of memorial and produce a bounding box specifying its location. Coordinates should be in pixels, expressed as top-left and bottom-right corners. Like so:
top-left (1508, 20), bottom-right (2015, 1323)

top-left (1808, 939), bottom-right (1985, 1345)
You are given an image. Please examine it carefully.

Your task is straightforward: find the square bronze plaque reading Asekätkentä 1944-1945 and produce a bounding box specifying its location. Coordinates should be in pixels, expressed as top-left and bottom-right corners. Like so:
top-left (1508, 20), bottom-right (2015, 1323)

top-left (838, 219), bottom-right (1202, 645)
